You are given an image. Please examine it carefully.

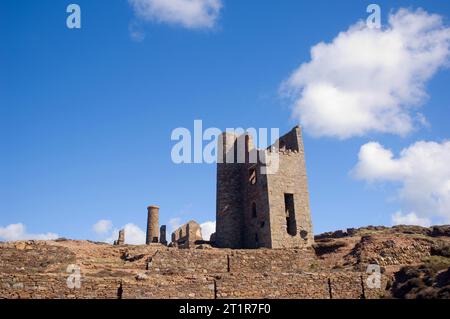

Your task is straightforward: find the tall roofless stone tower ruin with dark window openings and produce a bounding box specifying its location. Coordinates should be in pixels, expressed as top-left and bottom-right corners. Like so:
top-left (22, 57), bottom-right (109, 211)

top-left (215, 127), bottom-right (314, 249)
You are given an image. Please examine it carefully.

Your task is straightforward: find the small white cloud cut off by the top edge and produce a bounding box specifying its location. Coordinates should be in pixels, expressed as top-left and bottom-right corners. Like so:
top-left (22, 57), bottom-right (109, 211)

top-left (129, 0), bottom-right (223, 29)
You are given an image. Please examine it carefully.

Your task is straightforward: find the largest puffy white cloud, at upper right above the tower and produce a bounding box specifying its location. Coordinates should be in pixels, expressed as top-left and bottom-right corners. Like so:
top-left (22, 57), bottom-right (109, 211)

top-left (281, 9), bottom-right (450, 139)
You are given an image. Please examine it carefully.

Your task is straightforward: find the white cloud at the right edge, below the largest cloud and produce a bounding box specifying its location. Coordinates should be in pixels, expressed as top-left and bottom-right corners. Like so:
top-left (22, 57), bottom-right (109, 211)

top-left (352, 141), bottom-right (450, 224)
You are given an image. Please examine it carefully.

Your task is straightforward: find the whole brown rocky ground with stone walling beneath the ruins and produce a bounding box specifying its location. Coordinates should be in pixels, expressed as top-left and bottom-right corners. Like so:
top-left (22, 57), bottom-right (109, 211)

top-left (0, 226), bottom-right (450, 299)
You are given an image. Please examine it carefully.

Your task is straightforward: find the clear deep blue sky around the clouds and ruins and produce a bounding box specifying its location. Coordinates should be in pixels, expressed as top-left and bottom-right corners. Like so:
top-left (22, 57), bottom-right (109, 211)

top-left (0, 0), bottom-right (450, 244)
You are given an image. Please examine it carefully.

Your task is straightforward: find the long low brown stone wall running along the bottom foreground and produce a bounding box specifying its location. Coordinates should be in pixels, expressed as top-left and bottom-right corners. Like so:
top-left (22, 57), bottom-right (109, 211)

top-left (0, 272), bottom-right (386, 299)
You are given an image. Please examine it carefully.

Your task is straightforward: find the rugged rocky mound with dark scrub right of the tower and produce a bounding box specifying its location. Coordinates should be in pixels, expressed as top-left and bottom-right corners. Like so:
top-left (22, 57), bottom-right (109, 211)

top-left (315, 225), bottom-right (450, 299)
